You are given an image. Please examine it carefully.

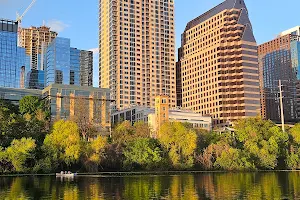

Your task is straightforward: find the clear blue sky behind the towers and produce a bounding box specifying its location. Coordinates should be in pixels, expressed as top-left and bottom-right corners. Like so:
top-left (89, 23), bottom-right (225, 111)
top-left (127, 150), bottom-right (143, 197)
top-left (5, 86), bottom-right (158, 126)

top-left (0, 0), bottom-right (300, 86)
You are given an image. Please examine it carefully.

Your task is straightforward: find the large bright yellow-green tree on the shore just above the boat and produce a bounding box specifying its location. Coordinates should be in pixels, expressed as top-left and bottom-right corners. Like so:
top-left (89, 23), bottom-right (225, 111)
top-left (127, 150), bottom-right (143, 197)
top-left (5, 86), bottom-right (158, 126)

top-left (43, 120), bottom-right (81, 169)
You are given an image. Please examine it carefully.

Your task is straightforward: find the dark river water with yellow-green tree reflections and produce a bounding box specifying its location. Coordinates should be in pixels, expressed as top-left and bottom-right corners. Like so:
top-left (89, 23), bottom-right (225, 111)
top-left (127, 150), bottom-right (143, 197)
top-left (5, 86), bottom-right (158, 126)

top-left (0, 172), bottom-right (300, 200)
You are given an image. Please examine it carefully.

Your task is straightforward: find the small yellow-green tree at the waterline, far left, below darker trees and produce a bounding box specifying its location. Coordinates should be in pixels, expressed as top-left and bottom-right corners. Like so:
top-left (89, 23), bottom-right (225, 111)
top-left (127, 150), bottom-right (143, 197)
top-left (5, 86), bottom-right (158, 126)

top-left (6, 138), bottom-right (36, 172)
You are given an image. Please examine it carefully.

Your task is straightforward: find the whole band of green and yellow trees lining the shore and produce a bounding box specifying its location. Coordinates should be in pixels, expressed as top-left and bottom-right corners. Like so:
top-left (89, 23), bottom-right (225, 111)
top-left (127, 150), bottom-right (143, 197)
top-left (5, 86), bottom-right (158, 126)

top-left (0, 96), bottom-right (300, 174)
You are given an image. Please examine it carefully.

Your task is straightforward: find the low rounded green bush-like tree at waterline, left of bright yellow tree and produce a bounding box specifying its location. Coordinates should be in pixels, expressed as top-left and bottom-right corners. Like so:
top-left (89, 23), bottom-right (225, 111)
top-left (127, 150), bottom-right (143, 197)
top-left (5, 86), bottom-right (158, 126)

top-left (124, 138), bottom-right (163, 170)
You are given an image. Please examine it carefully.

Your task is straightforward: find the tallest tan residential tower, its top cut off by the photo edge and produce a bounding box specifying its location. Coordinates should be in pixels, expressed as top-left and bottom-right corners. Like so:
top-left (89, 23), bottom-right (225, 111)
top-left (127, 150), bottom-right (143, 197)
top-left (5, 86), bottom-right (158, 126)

top-left (99, 0), bottom-right (176, 109)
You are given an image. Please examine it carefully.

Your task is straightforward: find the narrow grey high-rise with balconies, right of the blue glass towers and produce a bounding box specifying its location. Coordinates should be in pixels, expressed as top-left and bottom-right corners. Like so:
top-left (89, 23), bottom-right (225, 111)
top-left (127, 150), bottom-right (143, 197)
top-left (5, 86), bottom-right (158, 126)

top-left (80, 50), bottom-right (93, 86)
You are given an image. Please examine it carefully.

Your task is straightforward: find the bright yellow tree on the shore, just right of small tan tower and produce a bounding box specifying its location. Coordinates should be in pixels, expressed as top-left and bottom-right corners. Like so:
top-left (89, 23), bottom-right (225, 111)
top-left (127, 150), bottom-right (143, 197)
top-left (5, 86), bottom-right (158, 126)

top-left (158, 122), bottom-right (197, 169)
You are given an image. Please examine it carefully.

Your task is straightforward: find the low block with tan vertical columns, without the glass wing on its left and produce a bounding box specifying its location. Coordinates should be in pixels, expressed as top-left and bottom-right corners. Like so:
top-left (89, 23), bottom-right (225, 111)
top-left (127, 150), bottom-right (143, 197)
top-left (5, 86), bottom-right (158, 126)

top-left (42, 84), bottom-right (111, 132)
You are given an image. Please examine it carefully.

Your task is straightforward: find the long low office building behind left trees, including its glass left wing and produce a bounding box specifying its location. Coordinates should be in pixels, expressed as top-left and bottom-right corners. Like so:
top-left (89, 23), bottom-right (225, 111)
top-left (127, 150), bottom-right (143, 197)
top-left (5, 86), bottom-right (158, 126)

top-left (0, 84), bottom-right (111, 135)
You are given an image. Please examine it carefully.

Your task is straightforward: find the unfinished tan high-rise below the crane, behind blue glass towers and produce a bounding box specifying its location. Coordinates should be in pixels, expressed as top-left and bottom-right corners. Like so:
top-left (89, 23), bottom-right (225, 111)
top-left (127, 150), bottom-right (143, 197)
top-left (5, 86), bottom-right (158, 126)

top-left (20, 26), bottom-right (57, 70)
